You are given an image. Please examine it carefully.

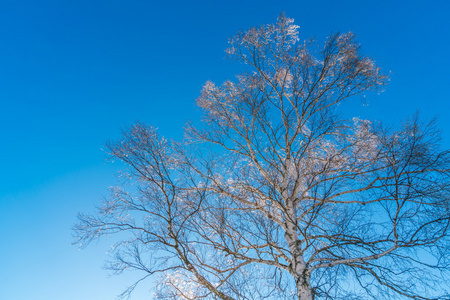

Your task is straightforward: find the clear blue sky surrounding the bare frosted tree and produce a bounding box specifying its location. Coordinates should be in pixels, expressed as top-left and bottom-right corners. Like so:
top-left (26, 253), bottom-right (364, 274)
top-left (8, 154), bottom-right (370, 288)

top-left (0, 0), bottom-right (450, 300)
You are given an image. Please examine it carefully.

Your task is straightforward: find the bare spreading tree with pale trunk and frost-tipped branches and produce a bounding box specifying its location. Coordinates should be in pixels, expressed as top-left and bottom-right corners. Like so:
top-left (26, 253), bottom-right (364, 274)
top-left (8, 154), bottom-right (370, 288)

top-left (75, 15), bottom-right (450, 300)
